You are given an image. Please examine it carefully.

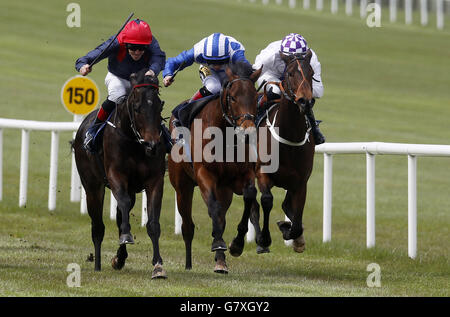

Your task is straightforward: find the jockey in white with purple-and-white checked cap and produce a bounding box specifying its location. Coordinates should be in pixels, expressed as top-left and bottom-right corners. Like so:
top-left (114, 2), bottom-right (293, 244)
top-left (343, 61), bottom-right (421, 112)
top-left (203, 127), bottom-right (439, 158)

top-left (253, 33), bottom-right (325, 144)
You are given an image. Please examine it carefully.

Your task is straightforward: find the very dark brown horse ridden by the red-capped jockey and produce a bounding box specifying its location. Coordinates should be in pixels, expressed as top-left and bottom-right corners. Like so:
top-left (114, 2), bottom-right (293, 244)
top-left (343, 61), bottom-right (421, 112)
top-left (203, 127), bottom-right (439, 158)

top-left (73, 69), bottom-right (166, 278)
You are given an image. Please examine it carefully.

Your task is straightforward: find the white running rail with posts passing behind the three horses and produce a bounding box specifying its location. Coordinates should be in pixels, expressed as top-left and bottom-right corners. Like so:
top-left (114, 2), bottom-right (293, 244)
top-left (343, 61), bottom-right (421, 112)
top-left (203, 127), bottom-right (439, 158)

top-left (0, 117), bottom-right (450, 258)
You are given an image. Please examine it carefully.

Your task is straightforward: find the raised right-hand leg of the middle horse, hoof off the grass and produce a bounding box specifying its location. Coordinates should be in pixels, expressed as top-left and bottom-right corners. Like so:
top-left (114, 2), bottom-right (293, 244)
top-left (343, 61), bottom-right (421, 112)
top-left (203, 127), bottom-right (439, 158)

top-left (230, 184), bottom-right (261, 256)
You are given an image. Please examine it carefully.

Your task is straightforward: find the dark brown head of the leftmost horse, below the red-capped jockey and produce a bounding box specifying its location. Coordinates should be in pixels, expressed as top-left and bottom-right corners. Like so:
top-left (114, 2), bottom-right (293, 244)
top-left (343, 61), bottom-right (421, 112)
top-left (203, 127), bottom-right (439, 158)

top-left (127, 69), bottom-right (164, 156)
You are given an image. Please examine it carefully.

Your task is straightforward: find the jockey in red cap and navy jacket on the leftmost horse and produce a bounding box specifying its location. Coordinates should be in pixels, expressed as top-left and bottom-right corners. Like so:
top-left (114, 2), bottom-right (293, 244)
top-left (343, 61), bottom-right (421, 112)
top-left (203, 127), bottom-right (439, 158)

top-left (75, 19), bottom-right (166, 152)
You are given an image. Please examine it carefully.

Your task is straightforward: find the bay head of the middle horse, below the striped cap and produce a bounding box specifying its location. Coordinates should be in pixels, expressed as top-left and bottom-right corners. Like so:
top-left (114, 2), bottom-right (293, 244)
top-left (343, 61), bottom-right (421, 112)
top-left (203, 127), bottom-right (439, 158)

top-left (220, 62), bottom-right (262, 130)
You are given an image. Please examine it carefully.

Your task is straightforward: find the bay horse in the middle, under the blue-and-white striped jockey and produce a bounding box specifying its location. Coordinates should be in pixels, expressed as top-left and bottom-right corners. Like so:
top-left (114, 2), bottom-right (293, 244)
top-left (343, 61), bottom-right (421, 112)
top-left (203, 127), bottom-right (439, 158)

top-left (168, 63), bottom-right (261, 274)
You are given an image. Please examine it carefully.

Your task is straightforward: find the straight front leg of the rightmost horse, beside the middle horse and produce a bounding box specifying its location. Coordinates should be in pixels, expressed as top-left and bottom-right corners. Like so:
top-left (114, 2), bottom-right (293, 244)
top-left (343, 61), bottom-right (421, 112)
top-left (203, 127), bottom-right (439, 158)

top-left (256, 173), bottom-right (273, 253)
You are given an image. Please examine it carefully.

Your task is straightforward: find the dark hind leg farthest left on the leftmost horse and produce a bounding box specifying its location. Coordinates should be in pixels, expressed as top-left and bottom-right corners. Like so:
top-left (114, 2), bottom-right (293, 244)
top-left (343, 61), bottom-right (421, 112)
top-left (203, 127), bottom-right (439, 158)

top-left (86, 184), bottom-right (105, 271)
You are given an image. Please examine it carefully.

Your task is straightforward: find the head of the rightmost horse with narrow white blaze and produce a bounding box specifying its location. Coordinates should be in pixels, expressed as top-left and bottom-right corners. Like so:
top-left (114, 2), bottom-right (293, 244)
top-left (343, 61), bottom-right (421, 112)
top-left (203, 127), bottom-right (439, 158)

top-left (280, 50), bottom-right (314, 112)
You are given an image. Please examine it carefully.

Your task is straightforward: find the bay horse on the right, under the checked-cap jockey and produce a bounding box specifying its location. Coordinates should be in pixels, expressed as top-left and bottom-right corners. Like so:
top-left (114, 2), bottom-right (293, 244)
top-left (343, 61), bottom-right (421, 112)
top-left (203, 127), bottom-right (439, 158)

top-left (232, 50), bottom-right (315, 253)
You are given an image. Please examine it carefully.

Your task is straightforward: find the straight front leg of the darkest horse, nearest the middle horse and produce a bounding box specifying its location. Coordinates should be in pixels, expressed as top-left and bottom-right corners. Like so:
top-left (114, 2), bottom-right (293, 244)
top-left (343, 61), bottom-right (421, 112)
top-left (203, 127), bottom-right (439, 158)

top-left (145, 175), bottom-right (167, 278)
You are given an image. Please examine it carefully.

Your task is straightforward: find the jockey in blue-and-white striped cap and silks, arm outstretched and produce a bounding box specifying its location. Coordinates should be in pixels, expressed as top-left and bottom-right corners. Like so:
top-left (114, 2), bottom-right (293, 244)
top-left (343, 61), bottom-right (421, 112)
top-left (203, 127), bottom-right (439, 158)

top-left (163, 33), bottom-right (251, 124)
